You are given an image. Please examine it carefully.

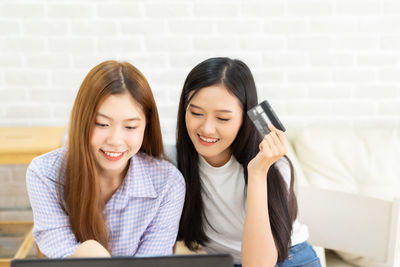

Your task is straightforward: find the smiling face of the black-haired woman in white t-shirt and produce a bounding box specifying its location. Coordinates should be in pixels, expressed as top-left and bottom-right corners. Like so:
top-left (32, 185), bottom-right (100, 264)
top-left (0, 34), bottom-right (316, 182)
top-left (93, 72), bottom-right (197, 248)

top-left (185, 84), bottom-right (243, 167)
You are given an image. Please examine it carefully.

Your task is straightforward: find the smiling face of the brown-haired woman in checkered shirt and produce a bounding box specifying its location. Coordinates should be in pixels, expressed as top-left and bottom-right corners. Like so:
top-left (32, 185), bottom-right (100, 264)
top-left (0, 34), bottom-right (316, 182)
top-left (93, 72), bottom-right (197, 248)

top-left (90, 93), bottom-right (146, 177)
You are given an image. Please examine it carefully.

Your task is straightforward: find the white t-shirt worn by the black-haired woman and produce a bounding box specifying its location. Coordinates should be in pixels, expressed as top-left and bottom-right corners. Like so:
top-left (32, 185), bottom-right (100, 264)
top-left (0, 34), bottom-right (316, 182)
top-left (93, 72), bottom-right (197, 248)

top-left (199, 155), bottom-right (308, 264)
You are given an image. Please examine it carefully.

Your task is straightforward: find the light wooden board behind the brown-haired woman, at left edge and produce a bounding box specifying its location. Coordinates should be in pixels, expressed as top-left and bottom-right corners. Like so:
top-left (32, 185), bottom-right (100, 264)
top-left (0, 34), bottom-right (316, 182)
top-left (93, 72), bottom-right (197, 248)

top-left (0, 127), bottom-right (65, 164)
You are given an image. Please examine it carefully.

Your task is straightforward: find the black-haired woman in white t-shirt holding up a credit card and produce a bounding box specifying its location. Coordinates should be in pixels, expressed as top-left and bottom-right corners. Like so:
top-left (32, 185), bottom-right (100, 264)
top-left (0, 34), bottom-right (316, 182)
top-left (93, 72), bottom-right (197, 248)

top-left (176, 58), bottom-right (320, 267)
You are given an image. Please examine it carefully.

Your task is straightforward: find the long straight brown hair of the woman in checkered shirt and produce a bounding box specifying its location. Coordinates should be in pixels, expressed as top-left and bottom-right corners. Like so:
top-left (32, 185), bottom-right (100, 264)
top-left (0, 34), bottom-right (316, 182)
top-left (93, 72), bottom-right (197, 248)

top-left (63, 61), bottom-right (165, 250)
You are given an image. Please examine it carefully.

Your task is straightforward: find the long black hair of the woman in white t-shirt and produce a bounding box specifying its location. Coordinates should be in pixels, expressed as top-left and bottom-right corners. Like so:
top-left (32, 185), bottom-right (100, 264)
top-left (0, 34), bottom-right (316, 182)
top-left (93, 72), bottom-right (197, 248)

top-left (176, 57), bottom-right (297, 261)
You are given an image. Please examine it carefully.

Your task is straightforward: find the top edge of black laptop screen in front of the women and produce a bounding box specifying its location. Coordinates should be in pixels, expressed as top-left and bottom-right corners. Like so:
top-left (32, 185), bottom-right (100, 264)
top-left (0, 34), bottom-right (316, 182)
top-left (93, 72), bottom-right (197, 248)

top-left (11, 254), bottom-right (233, 267)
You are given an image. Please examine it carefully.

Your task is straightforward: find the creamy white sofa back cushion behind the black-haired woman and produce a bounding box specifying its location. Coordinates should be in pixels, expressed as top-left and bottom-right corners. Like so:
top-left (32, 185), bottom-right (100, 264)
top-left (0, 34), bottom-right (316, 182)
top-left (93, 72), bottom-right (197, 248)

top-left (292, 128), bottom-right (400, 200)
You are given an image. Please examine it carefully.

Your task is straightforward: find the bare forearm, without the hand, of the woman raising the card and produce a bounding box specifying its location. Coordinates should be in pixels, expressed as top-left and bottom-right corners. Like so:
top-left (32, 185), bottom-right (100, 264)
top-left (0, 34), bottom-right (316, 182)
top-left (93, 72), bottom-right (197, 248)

top-left (242, 174), bottom-right (278, 267)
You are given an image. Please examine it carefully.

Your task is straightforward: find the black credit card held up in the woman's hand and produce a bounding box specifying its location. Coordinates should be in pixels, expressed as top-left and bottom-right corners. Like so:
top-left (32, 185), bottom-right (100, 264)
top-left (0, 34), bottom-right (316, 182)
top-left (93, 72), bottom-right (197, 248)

top-left (247, 100), bottom-right (286, 137)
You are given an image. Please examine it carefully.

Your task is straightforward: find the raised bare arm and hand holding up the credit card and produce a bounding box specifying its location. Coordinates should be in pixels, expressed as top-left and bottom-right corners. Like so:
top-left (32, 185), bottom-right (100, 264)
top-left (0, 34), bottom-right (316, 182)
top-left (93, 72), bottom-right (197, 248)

top-left (242, 125), bottom-right (286, 267)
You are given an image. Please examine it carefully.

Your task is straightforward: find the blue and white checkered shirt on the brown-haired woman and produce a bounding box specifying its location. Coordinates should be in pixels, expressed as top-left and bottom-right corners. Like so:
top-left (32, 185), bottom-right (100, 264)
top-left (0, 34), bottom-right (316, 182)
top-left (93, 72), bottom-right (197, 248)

top-left (26, 148), bottom-right (185, 258)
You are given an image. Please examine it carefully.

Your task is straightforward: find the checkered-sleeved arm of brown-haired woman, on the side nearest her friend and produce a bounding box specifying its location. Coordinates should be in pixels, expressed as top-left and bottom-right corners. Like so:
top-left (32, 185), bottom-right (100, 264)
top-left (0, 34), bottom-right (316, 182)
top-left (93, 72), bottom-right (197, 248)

top-left (136, 167), bottom-right (185, 255)
